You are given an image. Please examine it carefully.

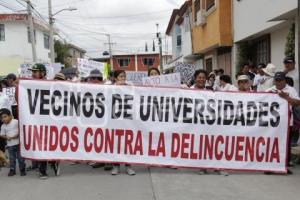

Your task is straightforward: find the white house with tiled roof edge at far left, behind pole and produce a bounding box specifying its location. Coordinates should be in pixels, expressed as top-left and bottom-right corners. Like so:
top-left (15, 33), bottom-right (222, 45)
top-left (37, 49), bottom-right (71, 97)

top-left (0, 14), bottom-right (50, 73)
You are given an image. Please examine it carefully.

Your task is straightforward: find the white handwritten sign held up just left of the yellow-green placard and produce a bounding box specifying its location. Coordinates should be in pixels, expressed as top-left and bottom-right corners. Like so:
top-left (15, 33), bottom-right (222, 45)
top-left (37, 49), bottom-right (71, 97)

top-left (77, 58), bottom-right (105, 78)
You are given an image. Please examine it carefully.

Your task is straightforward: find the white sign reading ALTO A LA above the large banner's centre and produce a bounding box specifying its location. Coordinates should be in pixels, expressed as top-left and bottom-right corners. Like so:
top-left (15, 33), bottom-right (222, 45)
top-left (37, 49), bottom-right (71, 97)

top-left (143, 73), bottom-right (181, 87)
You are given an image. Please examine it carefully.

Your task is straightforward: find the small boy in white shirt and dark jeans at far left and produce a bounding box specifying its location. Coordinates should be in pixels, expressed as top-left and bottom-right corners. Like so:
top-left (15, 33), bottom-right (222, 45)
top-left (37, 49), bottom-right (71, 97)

top-left (0, 108), bottom-right (26, 176)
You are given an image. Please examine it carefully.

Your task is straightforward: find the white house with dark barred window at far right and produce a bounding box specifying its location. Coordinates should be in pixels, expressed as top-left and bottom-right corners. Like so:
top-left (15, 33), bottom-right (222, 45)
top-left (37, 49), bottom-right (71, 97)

top-left (233, 0), bottom-right (299, 92)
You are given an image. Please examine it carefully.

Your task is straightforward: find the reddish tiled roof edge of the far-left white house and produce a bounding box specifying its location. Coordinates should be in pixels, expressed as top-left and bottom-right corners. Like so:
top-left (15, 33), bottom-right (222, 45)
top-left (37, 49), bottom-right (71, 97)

top-left (0, 13), bottom-right (49, 32)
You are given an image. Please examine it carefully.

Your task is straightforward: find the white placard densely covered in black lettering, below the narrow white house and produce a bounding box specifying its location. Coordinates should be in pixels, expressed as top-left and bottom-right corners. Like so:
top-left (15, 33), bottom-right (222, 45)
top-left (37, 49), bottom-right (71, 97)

top-left (174, 62), bottom-right (196, 85)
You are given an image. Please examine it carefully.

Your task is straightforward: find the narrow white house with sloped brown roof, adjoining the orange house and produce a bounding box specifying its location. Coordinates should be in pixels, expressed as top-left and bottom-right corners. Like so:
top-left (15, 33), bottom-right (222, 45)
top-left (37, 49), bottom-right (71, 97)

top-left (164, 0), bottom-right (203, 70)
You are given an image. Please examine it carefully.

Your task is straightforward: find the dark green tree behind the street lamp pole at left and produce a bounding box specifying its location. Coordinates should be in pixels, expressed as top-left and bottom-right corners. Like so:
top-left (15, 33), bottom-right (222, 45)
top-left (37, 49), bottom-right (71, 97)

top-left (54, 40), bottom-right (70, 67)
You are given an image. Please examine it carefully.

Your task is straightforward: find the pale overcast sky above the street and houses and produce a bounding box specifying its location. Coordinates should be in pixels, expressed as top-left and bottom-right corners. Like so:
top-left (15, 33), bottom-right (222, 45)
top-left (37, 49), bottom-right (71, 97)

top-left (0, 0), bottom-right (185, 57)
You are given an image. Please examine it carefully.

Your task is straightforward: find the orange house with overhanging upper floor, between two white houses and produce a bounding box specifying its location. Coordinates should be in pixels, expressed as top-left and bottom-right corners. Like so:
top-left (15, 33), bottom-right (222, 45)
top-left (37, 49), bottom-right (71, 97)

top-left (192, 0), bottom-right (233, 74)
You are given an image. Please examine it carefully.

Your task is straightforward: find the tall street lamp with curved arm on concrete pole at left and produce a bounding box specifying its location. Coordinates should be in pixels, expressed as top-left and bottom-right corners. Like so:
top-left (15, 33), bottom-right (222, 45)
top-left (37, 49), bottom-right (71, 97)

top-left (48, 0), bottom-right (77, 63)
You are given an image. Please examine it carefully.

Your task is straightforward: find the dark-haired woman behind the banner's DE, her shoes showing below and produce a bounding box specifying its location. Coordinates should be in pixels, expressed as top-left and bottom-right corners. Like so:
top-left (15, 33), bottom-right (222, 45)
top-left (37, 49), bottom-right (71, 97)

top-left (111, 70), bottom-right (135, 176)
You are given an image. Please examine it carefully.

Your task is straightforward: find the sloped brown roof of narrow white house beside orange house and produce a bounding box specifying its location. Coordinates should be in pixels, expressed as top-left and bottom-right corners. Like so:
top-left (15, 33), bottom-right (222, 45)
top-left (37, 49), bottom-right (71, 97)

top-left (166, 0), bottom-right (192, 35)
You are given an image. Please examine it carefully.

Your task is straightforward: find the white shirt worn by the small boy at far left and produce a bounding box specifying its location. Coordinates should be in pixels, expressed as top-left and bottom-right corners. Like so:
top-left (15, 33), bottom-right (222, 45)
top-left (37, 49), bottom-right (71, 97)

top-left (0, 119), bottom-right (20, 147)
